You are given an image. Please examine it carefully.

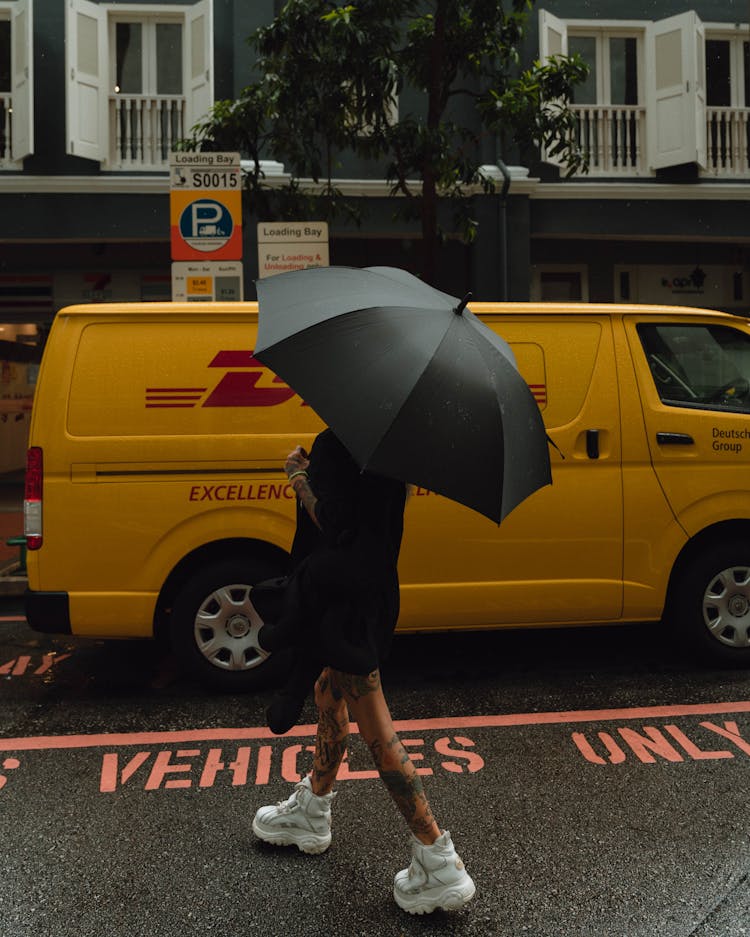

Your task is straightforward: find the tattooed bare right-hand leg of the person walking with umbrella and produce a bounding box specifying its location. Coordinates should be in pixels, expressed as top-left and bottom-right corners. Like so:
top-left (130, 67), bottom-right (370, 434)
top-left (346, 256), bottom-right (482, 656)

top-left (335, 670), bottom-right (440, 845)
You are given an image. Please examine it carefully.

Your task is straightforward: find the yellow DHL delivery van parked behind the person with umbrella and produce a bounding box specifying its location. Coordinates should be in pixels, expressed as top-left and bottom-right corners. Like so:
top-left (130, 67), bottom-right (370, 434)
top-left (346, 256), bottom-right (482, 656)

top-left (20, 303), bottom-right (750, 689)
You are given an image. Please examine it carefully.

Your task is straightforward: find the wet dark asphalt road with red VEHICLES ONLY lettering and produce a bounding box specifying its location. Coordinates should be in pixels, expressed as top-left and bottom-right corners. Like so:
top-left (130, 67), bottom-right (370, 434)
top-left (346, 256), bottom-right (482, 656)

top-left (0, 599), bottom-right (750, 937)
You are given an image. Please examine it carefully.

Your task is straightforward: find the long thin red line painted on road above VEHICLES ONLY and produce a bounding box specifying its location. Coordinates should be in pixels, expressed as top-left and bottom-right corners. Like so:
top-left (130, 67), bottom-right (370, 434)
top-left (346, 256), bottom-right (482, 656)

top-left (0, 700), bottom-right (750, 752)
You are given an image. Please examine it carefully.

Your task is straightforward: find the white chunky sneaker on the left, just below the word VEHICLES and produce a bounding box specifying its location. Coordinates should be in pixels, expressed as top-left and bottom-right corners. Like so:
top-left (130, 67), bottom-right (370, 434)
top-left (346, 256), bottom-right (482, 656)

top-left (253, 776), bottom-right (336, 854)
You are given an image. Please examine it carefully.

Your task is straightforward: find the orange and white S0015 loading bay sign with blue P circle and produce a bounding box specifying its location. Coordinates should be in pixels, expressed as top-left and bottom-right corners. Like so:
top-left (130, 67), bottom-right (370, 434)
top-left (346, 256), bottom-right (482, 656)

top-left (169, 153), bottom-right (242, 261)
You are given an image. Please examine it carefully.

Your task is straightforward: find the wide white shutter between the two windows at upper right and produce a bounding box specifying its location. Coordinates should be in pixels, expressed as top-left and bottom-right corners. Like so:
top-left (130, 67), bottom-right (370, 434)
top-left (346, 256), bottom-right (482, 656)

top-left (646, 10), bottom-right (706, 169)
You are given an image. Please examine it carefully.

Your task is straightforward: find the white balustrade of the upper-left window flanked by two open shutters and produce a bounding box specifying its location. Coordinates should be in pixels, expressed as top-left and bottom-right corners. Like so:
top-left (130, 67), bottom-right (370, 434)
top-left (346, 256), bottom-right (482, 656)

top-left (109, 94), bottom-right (185, 170)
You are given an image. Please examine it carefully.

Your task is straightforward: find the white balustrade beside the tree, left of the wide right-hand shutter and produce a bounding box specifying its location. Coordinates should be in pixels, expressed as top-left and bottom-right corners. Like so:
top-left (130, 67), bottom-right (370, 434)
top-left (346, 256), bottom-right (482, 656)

top-left (571, 104), bottom-right (646, 176)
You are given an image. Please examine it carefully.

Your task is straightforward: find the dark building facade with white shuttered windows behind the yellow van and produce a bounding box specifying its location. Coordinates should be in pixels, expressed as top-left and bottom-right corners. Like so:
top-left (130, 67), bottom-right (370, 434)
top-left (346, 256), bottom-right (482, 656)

top-left (0, 0), bottom-right (750, 473)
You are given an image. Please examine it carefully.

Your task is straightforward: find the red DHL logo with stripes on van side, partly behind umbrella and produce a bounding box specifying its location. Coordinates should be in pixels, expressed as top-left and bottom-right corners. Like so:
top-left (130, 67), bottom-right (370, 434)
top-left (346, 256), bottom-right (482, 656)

top-left (146, 351), bottom-right (547, 409)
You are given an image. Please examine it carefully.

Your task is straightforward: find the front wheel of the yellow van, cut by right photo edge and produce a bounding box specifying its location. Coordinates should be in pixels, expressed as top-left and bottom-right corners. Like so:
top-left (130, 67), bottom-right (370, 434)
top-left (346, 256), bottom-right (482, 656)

top-left (671, 540), bottom-right (750, 667)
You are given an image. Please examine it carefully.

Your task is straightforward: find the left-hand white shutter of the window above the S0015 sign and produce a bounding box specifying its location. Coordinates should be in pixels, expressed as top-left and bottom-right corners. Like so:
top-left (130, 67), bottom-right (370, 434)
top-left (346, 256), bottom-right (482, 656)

top-left (65, 0), bottom-right (109, 162)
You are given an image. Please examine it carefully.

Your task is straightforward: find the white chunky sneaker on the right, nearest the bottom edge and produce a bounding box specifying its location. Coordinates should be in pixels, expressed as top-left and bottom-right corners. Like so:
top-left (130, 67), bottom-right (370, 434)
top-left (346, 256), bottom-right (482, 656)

top-left (393, 830), bottom-right (476, 914)
